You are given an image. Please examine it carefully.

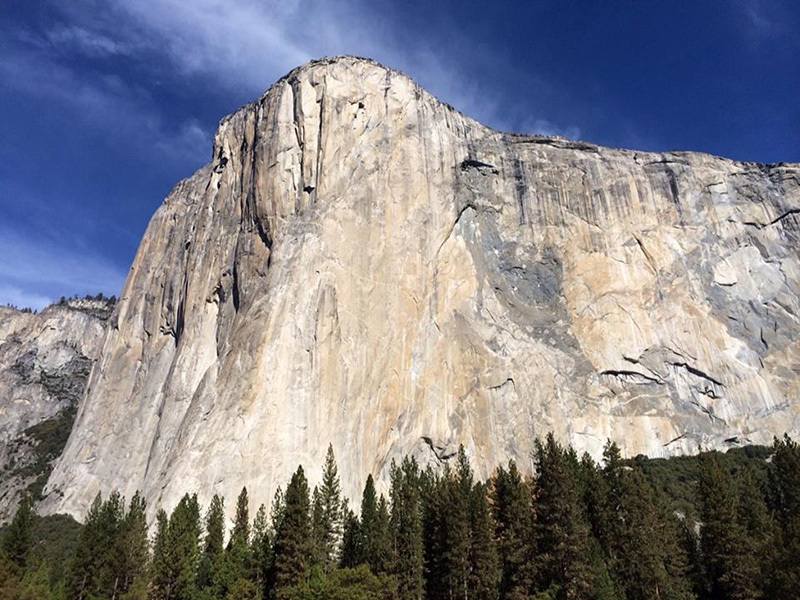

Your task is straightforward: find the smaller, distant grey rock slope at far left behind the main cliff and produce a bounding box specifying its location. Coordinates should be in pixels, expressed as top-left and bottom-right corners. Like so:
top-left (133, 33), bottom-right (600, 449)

top-left (0, 300), bottom-right (112, 523)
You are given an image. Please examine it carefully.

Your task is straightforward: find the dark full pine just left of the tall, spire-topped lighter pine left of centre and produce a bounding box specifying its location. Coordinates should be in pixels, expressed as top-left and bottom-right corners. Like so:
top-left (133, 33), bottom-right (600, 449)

top-left (274, 467), bottom-right (314, 599)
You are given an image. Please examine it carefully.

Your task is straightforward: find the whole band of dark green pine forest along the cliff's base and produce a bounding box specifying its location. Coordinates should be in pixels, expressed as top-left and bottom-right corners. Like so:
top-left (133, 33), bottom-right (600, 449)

top-left (0, 436), bottom-right (800, 600)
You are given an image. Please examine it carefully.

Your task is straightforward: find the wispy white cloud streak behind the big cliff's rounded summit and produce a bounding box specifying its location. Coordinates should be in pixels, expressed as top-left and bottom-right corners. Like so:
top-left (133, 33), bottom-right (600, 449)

top-left (51, 0), bottom-right (569, 132)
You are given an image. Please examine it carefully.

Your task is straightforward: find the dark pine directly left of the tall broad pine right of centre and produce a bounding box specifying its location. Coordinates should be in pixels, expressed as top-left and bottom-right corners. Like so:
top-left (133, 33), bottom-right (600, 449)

top-left (491, 460), bottom-right (533, 600)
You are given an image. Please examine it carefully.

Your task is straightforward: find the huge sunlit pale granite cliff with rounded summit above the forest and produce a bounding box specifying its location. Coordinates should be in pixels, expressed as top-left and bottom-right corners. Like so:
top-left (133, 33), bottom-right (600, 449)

top-left (46, 57), bottom-right (800, 515)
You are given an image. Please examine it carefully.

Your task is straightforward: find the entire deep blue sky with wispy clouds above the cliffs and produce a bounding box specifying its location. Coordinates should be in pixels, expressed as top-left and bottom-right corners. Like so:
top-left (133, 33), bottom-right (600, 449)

top-left (0, 0), bottom-right (800, 308)
